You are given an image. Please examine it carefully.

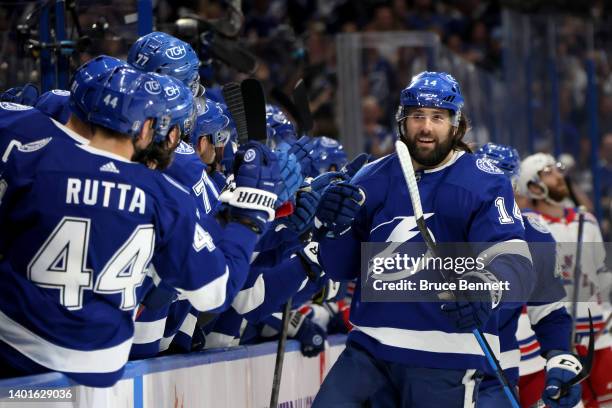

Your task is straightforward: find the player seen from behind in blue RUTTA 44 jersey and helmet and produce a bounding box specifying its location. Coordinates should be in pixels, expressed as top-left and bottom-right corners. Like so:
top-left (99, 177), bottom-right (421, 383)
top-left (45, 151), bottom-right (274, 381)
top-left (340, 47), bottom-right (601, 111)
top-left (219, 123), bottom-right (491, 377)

top-left (0, 63), bottom-right (278, 386)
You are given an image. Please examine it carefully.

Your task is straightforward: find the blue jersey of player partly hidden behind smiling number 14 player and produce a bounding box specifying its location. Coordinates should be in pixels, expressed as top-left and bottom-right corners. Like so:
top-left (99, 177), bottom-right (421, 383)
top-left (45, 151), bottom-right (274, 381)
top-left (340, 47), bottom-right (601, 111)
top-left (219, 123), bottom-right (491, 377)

top-left (481, 215), bottom-right (572, 387)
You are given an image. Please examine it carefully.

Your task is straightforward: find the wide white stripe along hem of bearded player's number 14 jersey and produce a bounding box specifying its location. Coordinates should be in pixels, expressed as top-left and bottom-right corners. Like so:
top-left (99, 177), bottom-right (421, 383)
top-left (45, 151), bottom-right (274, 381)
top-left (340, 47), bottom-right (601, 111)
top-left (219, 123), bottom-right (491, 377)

top-left (353, 326), bottom-right (500, 359)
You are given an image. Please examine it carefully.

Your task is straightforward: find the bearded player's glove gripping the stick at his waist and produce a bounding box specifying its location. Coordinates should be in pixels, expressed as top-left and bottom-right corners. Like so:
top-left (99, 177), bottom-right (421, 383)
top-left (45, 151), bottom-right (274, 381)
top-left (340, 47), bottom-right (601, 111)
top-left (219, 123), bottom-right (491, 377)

top-left (442, 270), bottom-right (501, 330)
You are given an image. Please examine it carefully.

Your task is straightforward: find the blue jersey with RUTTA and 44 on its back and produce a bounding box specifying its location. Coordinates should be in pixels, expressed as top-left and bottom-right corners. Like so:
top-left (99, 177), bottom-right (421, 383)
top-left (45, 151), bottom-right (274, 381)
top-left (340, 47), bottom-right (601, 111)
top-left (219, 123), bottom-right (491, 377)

top-left (0, 135), bottom-right (256, 386)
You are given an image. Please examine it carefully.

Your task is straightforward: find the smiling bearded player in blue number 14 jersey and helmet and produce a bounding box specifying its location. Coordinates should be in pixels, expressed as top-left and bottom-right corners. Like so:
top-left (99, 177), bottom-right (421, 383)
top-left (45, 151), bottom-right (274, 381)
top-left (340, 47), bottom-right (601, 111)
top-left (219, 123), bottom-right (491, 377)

top-left (313, 72), bottom-right (533, 407)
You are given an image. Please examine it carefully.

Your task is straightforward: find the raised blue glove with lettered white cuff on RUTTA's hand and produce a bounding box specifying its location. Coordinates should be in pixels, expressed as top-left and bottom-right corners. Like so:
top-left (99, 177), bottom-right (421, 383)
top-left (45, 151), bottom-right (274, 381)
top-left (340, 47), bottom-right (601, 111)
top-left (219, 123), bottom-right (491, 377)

top-left (219, 142), bottom-right (281, 233)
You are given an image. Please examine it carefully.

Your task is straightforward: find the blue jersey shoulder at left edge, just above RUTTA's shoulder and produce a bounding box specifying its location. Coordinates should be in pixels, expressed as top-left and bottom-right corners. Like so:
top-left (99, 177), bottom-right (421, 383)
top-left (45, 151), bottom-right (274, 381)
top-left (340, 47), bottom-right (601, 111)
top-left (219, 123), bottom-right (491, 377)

top-left (0, 102), bottom-right (87, 154)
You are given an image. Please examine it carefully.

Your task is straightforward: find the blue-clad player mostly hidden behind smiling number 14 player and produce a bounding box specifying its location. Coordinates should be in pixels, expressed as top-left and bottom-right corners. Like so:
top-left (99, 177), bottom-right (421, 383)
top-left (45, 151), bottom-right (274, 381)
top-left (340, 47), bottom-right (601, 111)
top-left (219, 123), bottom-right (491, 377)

top-left (476, 143), bottom-right (581, 408)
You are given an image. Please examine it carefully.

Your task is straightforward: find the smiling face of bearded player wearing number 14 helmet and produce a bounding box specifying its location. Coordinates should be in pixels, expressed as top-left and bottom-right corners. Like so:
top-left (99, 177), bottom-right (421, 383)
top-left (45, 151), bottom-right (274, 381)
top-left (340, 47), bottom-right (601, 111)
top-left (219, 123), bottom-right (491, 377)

top-left (404, 108), bottom-right (455, 167)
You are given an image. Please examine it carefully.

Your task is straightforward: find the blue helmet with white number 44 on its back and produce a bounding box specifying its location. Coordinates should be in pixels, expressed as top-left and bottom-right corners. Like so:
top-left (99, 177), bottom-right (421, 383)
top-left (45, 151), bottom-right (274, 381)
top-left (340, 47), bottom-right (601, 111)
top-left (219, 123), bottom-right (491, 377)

top-left (70, 66), bottom-right (172, 142)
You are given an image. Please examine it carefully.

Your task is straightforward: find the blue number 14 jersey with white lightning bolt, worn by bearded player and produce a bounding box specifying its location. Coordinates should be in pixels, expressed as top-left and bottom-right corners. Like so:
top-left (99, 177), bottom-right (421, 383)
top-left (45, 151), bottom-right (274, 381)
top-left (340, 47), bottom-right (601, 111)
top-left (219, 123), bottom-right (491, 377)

top-left (319, 152), bottom-right (533, 371)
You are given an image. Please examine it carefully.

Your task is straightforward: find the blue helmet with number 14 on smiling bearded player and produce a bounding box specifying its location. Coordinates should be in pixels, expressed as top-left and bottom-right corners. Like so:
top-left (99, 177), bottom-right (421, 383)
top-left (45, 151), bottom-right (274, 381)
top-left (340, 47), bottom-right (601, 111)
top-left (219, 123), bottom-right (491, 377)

top-left (395, 71), bottom-right (464, 126)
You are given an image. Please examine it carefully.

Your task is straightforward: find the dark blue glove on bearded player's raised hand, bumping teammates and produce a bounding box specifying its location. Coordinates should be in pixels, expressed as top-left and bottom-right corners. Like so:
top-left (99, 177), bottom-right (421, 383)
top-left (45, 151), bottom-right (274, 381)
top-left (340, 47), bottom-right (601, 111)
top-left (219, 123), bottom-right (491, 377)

top-left (315, 182), bottom-right (365, 238)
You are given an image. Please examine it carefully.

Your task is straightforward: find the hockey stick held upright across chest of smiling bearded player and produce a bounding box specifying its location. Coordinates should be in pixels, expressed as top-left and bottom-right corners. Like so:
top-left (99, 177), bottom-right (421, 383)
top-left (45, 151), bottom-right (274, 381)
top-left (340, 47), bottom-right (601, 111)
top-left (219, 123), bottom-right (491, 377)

top-left (395, 140), bottom-right (520, 408)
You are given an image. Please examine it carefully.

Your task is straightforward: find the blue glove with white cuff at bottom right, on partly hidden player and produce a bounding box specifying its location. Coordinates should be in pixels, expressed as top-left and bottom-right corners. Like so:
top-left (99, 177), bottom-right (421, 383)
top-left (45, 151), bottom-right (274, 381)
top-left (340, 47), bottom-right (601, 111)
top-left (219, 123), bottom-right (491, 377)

top-left (542, 351), bottom-right (582, 408)
